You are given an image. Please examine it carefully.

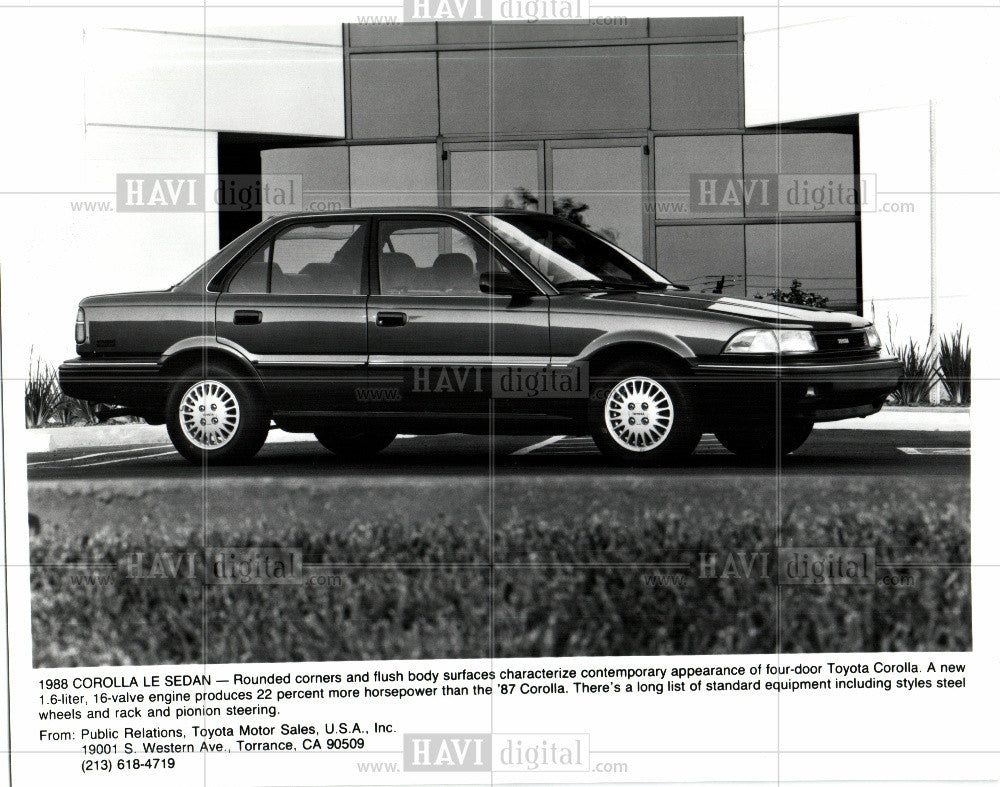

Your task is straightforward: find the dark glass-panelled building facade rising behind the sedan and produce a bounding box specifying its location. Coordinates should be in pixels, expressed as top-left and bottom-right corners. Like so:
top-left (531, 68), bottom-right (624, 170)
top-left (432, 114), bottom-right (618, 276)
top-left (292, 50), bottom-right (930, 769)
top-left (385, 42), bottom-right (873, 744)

top-left (262, 17), bottom-right (864, 310)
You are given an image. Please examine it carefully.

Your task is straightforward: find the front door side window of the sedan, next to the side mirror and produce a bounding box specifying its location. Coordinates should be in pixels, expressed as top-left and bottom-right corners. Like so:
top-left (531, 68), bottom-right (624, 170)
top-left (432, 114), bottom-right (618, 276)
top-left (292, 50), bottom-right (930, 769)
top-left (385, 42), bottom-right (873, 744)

top-left (378, 219), bottom-right (506, 295)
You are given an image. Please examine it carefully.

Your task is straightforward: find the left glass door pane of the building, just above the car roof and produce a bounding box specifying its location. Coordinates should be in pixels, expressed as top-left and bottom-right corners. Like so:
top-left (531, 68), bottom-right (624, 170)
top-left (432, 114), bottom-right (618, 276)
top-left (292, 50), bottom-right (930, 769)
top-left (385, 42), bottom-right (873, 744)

top-left (448, 150), bottom-right (543, 210)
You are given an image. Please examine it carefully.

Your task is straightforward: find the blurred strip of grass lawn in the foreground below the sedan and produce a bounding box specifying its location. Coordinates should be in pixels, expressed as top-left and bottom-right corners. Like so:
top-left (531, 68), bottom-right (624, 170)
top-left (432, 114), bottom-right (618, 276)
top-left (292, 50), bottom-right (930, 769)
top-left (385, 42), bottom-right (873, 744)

top-left (29, 474), bottom-right (972, 667)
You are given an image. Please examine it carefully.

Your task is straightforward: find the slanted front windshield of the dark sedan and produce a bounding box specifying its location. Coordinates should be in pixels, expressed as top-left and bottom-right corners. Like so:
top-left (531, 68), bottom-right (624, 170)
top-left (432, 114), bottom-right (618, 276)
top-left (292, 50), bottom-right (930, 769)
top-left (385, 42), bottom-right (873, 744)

top-left (479, 214), bottom-right (671, 290)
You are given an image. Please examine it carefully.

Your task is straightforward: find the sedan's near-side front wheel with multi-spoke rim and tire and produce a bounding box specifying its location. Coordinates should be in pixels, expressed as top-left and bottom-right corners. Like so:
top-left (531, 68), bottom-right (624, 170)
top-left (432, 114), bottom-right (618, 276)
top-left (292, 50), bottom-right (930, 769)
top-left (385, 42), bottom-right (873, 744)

top-left (588, 361), bottom-right (701, 466)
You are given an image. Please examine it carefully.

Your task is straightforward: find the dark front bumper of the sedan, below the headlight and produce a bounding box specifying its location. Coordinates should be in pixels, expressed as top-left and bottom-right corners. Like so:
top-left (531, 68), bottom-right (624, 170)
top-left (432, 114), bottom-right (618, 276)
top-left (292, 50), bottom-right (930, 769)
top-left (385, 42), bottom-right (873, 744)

top-left (693, 358), bottom-right (903, 421)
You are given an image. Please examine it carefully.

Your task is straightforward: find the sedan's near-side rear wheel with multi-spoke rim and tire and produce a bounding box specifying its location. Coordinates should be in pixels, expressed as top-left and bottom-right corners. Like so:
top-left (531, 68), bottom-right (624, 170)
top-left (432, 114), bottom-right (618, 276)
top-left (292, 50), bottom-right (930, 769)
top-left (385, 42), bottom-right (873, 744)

top-left (166, 363), bottom-right (271, 464)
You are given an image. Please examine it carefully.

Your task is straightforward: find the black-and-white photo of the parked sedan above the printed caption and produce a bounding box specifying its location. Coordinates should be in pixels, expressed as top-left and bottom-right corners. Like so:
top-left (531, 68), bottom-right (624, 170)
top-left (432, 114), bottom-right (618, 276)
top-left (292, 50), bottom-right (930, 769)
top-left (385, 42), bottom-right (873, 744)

top-left (11, 13), bottom-right (972, 667)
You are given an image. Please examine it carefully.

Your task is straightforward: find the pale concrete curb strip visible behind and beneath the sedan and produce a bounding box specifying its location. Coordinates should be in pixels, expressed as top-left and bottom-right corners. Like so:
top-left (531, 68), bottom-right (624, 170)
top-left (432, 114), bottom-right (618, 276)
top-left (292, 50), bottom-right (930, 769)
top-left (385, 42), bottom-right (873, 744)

top-left (25, 407), bottom-right (970, 454)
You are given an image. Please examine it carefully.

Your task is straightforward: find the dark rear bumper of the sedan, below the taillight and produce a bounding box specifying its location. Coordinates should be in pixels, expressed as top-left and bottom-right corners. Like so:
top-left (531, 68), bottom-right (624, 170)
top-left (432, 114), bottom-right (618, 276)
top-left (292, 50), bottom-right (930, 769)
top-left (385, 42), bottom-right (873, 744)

top-left (59, 358), bottom-right (164, 408)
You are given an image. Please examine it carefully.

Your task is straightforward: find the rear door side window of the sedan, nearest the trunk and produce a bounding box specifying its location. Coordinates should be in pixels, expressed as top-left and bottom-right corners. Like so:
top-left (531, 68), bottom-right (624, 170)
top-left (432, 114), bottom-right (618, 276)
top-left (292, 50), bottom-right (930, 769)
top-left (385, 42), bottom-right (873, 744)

top-left (229, 222), bottom-right (367, 295)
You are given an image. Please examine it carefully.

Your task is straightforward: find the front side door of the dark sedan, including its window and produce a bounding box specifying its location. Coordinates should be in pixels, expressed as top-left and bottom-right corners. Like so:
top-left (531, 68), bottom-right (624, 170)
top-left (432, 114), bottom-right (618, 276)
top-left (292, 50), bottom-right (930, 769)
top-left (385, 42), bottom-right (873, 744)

top-left (368, 215), bottom-right (549, 419)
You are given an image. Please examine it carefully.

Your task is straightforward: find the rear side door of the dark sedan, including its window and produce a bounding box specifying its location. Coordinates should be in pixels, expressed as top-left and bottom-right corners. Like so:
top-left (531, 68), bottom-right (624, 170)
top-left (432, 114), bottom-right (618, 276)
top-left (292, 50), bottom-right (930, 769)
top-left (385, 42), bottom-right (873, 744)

top-left (215, 217), bottom-right (369, 415)
